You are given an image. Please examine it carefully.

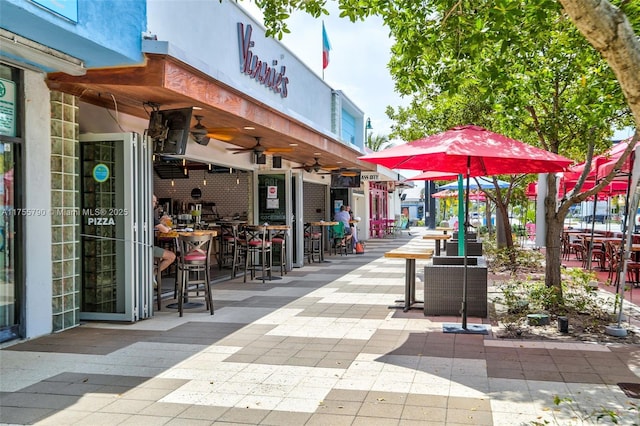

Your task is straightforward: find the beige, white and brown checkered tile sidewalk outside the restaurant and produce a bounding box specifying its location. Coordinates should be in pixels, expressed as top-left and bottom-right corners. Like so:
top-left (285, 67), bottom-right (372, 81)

top-left (0, 237), bottom-right (640, 426)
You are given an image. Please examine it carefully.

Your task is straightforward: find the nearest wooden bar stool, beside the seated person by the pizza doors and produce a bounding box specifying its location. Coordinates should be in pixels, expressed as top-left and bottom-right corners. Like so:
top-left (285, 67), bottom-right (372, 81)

top-left (178, 234), bottom-right (213, 316)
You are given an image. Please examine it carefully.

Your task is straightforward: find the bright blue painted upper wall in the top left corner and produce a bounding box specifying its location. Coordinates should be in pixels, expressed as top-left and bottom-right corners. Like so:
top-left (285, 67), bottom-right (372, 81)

top-left (0, 0), bottom-right (147, 68)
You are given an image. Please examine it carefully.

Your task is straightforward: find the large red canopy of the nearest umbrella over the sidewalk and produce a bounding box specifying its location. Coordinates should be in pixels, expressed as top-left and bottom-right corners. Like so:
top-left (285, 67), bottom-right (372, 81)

top-left (360, 125), bottom-right (573, 176)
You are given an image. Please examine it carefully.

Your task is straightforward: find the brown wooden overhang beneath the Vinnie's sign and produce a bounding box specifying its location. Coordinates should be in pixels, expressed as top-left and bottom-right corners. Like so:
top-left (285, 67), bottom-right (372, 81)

top-left (47, 54), bottom-right (375, 170)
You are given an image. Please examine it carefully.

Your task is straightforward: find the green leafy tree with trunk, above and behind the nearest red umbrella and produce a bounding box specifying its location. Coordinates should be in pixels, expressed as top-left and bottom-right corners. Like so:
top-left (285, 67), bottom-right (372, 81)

top-left (255, 0), bottom-right (640, 298)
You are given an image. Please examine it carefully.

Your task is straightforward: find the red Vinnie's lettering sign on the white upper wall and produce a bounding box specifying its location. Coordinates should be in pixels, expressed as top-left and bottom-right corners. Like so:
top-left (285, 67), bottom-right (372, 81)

top-left (238, 22), bottom-right (289, 98)
